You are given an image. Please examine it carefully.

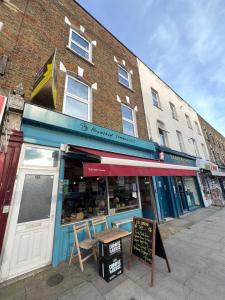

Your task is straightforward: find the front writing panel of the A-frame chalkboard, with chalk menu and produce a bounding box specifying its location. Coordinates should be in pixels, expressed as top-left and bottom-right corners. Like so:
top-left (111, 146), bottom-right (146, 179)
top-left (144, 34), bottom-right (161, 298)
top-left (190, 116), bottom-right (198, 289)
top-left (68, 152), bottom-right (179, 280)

top-left (132, 218), bottom-right (155, 264)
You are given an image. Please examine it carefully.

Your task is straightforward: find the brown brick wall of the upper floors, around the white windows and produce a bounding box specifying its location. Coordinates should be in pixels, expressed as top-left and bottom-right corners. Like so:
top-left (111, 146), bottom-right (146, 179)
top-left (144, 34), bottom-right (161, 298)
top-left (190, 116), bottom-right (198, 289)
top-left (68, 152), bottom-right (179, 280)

top-left (0, 0), bottom-right (147, 139)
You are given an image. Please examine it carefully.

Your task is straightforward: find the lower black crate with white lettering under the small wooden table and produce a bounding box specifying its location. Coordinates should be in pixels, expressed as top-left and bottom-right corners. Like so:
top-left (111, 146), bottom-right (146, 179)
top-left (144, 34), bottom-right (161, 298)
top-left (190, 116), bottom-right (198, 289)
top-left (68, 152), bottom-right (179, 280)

top-left (99, 254), bottom-right (123, 282)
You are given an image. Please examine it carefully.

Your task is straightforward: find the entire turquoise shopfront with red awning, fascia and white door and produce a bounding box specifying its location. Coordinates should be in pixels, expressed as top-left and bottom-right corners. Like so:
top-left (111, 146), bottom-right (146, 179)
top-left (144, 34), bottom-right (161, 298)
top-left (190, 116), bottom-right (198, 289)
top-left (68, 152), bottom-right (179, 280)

top-left (1, 104), bottom-right (200, 281)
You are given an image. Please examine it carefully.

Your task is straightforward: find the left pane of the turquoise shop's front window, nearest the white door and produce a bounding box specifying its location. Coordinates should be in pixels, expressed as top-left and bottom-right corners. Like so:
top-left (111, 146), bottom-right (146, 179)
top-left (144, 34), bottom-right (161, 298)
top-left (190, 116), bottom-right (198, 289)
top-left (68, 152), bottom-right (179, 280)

top-left (62, 161), bottom-right (108, 224)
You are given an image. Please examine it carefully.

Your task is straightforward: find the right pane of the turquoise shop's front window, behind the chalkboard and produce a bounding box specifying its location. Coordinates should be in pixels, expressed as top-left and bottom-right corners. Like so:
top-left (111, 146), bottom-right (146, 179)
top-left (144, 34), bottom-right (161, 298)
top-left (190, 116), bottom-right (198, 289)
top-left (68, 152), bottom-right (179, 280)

top-left (108, 176), bottom-right (139, 214)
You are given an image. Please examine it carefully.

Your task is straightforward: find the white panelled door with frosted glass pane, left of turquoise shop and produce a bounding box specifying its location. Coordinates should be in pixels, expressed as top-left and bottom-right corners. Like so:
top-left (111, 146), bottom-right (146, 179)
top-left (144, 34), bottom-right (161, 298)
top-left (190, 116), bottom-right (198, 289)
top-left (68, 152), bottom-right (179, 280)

top-left (1, 170), bottom-right (58, 281)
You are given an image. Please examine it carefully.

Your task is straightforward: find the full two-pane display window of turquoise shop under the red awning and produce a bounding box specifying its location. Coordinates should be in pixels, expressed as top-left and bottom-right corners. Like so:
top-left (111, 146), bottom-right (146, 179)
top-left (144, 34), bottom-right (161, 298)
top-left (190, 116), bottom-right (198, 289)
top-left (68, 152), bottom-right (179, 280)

top-left (62, 158), bottom-right (139, 224)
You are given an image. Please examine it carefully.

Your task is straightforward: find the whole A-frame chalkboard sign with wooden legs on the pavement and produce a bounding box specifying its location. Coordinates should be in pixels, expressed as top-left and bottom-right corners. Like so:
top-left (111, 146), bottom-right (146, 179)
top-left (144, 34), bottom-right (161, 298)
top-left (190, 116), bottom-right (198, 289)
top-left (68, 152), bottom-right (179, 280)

top-left (129, 217), bottom-right (171, 286)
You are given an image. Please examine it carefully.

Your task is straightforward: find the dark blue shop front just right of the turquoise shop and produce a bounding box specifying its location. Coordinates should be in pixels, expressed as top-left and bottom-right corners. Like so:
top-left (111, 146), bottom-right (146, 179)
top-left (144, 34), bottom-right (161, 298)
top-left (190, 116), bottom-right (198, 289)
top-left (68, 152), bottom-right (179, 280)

top-left (155, 147), bottom-right (204, 220)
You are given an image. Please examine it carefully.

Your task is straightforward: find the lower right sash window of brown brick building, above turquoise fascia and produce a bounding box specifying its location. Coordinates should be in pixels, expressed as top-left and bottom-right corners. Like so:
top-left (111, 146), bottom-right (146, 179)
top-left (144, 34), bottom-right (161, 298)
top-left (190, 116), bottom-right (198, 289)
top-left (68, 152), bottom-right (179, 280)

top-left (121, 104), bottom-right (137, 136)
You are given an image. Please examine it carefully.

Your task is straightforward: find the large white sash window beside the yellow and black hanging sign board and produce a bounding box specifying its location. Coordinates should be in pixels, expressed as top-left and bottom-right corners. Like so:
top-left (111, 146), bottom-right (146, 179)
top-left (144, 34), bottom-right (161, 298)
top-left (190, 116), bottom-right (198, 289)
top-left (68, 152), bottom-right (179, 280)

top-left (63, 76), bottom-right (91, 121)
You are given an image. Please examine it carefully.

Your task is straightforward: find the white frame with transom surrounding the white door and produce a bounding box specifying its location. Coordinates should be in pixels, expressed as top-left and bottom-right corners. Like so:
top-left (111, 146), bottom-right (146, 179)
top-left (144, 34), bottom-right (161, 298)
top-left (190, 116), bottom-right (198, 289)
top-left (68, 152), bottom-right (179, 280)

top-left (0, 144), bottom-right (60, 282)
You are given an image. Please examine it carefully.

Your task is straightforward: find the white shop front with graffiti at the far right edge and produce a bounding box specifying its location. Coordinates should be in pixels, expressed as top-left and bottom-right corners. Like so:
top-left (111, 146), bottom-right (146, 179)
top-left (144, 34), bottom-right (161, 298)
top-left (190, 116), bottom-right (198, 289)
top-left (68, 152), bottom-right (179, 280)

top-left (196, 159), bottom-right (225, 206)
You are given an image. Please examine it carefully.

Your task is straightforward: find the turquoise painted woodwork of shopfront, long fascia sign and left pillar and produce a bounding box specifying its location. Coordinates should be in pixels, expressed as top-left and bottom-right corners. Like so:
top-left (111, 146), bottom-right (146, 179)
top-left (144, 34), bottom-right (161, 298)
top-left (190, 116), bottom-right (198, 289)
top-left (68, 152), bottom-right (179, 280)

top-left (22, 104), bottom-right (156, 266)
